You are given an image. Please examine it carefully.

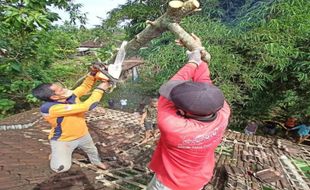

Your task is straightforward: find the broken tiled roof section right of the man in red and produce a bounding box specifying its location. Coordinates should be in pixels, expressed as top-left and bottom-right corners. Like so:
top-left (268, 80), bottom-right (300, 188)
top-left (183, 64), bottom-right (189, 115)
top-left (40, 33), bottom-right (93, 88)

top-left (209, 131), bottom-right (310, 190)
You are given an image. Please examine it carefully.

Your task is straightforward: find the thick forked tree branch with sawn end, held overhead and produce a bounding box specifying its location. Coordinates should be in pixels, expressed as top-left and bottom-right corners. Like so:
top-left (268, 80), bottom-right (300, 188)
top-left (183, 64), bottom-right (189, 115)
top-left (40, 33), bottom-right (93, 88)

top-left (109, 0), bottom-right (211, 67)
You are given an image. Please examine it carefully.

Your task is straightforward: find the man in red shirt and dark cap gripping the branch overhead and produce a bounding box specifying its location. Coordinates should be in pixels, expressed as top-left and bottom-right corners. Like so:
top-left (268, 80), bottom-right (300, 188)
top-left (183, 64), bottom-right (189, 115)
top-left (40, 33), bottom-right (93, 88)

top-left (147, 35), bottom-right (230, 190)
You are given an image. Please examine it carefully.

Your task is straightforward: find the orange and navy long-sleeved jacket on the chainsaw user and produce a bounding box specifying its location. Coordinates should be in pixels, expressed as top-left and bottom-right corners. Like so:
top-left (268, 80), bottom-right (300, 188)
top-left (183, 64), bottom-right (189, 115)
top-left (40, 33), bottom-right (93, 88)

top-left (41, 75), bottom-right (103, 141)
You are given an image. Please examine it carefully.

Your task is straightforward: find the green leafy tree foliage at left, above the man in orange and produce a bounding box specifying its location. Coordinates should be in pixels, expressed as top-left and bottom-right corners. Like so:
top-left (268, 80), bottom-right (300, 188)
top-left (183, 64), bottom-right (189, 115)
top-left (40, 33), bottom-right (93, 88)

top-left (0, 0), bottom-right (82, 114)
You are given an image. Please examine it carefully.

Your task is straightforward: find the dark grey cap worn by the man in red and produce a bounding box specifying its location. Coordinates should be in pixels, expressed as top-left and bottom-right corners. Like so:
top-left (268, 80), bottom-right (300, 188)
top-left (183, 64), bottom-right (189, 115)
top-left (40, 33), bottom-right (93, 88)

top-left (159, 80), bottom-right (225, 116)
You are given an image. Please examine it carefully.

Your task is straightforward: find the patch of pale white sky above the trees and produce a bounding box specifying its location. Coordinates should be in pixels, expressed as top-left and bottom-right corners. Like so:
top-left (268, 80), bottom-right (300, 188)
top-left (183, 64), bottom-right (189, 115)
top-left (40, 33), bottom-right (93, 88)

top-left (52, 0), bottom-right (127, 28)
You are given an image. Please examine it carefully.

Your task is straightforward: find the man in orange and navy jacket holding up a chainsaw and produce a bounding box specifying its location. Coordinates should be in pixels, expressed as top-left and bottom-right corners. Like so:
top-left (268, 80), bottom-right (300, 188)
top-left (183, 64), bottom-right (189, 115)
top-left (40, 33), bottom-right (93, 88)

top-left (32, 71), bottom-right (109, 173)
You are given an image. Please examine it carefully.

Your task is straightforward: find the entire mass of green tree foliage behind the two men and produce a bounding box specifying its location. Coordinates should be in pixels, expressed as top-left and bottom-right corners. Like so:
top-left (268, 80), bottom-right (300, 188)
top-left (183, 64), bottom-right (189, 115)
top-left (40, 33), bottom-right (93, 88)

top-left (0, 0), bottom-right (310, 126)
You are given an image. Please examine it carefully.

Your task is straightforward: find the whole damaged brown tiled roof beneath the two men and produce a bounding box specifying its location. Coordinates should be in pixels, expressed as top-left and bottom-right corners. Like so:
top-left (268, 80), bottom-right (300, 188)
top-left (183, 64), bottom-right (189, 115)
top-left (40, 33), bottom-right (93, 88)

top-left (0, 108), bottom-right (310, 190)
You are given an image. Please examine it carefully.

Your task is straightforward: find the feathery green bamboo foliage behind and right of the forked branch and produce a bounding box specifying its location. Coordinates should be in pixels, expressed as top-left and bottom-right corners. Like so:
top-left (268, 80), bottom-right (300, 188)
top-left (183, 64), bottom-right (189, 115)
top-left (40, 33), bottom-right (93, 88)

top-left (105, 0), bottom-right (310, 125)
